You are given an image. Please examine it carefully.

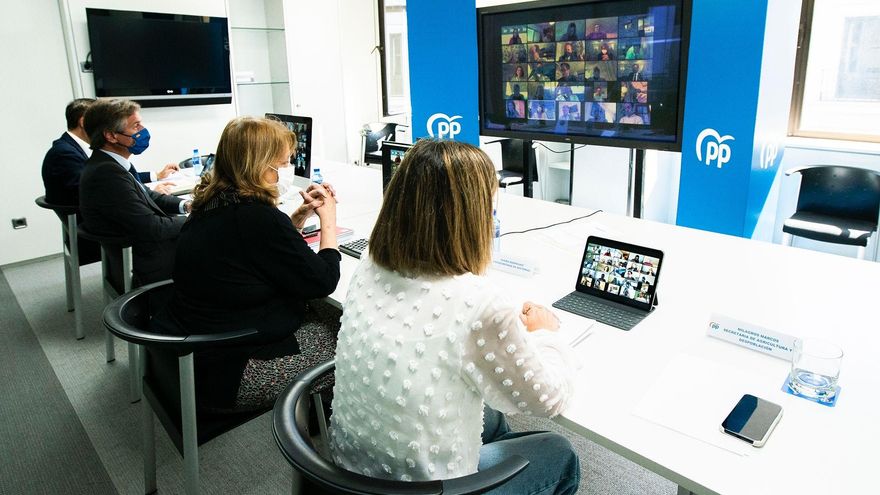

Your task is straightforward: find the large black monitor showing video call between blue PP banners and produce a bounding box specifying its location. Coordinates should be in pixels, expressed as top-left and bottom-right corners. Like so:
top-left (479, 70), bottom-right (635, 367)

top-left (477, 0), bottom-right (690, 151)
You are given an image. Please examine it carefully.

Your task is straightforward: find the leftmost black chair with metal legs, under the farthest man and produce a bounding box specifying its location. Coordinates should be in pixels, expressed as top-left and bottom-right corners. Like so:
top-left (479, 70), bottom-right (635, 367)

top-left (34, 196), bottom-right (97, 340)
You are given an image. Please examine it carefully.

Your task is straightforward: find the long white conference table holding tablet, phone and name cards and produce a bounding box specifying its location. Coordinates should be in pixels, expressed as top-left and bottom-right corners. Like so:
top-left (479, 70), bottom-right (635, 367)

top-left (281, 163), bottom-right (880, 495)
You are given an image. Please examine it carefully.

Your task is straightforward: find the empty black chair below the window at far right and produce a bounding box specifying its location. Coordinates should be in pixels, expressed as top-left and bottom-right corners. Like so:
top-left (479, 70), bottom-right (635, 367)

top-left (782, 165), bottom-right (880, 259)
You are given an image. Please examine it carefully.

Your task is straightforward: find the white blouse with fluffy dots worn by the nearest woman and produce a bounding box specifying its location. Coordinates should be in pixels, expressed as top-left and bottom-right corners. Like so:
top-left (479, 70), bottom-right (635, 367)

top-left (330, 257), bottom-right (575, 481)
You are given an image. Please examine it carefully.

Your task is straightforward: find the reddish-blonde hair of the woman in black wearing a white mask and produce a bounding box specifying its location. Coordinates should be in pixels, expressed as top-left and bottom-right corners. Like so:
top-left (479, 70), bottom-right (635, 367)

top-left (192, 117), bottom-right (296, 211)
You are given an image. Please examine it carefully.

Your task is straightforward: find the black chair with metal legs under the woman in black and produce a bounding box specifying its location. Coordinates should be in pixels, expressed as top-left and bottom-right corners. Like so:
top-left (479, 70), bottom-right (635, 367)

top-left (104, 280), bottom-right (269, 495)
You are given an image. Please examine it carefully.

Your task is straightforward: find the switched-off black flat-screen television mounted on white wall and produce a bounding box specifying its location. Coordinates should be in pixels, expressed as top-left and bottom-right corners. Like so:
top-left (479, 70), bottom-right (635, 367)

top-left (86, 9), bottom-right (232, 107)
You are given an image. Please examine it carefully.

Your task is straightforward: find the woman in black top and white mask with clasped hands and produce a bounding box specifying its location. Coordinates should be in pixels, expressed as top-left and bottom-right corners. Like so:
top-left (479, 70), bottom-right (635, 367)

top-left (153, 117), bottom-right (340, 410)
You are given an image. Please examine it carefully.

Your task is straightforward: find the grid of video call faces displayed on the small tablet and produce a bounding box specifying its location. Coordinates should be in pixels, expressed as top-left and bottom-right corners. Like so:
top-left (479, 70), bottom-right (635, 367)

top-left (578, 243), bottom-right (660, 304)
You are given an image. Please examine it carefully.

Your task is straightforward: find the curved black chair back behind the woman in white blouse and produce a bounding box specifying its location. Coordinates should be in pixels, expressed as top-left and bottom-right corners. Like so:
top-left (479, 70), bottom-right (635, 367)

top-left (272, 361), bottom-right (529, 495)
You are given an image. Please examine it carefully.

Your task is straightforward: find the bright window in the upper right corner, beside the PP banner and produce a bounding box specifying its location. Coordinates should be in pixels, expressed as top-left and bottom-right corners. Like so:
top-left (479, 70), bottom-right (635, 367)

top-left (789, 0), bottom-right (880, 142)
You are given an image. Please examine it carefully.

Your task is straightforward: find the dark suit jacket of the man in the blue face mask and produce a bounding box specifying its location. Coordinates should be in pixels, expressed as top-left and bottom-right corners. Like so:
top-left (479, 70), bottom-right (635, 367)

top-left (79, 150), bottom-right (186, 284)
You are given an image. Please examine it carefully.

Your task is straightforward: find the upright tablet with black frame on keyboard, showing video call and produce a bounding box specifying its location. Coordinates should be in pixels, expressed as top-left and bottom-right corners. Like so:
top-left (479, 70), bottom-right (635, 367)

top-left (577, 237), bottom-right (663, 309)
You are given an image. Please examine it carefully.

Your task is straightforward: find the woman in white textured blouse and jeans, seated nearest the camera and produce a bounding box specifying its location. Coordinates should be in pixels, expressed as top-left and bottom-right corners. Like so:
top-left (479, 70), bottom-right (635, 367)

top-left (330, 140), bottom-right (580, 494)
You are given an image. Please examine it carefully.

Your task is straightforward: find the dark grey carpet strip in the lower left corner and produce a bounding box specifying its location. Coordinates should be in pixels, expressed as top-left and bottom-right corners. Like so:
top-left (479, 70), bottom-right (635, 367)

top-left (0, 266), bottom-right (116, 494)
